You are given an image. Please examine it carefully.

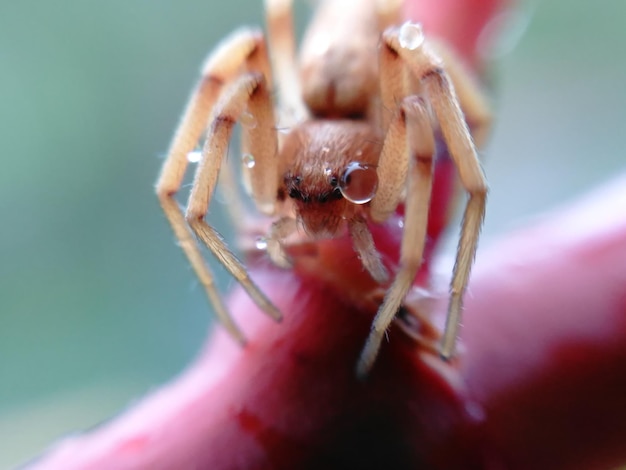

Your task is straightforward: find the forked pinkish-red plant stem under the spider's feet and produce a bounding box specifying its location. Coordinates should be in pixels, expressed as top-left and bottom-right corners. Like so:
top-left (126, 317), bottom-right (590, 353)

top-left (33, 175), bottom-right (626, 469)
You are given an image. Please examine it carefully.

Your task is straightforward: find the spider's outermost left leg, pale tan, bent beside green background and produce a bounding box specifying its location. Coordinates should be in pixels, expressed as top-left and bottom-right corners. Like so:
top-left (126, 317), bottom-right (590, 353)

top-left (156, 30), bottom-right (280, 343)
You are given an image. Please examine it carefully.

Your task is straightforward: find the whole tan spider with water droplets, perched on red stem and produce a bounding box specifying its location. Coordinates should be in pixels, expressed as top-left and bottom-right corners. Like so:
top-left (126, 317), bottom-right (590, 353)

top-left (156, 0), bottom-right (490, 377)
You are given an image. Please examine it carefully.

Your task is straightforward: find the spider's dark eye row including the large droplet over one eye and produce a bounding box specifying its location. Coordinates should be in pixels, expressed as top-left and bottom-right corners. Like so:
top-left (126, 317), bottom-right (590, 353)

top-left (285, 162), bottom-right (378, 204)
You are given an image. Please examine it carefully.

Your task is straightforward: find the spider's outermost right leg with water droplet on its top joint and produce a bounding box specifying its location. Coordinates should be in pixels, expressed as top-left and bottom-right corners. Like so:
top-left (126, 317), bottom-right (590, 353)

top-left (388, 24), bottom-right (487, 359)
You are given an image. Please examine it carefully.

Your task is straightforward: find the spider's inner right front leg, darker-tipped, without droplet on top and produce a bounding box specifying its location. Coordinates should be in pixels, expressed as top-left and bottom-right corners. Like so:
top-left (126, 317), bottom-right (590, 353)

top-left (357, 97), bottom-right (435, 378)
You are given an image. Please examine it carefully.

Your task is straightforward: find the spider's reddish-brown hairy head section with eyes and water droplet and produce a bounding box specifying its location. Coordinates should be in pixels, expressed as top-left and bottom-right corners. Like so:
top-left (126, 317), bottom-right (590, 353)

top-left (278, 120), bottom-right (381, 237)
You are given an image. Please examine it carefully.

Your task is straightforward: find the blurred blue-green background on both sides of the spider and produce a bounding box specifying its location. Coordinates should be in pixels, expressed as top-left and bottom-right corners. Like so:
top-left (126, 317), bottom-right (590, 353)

top-left (0, 0), bottom-right (626, 468)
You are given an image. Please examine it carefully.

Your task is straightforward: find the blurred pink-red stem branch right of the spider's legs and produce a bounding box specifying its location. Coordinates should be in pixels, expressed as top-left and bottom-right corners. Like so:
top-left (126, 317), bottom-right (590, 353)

top-left (460, 175), bottom-right (626, 469)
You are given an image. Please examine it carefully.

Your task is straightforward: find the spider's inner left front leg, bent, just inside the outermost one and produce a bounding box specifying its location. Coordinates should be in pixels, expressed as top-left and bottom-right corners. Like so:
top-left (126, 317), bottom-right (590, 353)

top-left (185, 73), bottom-right (281, 320)
